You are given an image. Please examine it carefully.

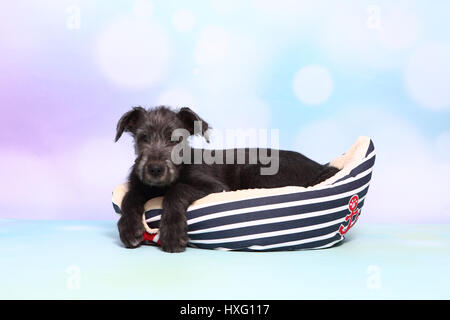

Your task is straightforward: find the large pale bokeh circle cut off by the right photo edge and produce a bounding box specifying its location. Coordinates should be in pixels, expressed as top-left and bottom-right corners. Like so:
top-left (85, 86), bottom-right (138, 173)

top-left (404, 44), bottom-right (450, 110)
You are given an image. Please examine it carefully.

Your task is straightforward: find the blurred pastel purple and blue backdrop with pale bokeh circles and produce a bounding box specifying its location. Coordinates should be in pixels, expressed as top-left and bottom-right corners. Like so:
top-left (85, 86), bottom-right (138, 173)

top-left (0, 0), bottom-right (450, 223)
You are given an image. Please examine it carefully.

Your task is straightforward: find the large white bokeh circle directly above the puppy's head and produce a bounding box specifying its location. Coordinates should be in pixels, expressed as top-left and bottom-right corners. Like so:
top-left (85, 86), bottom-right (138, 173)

top-left (96, 18), bottom-right (170, 88)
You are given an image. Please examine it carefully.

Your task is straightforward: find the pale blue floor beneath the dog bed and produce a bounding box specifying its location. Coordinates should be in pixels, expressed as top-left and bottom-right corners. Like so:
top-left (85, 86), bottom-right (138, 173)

top-left (0, 220), bottom-right (450, 299)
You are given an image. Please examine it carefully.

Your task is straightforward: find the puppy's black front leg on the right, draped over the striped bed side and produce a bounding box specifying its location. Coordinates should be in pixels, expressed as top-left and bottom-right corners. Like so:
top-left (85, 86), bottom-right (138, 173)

top-left (159, 182), bottom-right (227, 252)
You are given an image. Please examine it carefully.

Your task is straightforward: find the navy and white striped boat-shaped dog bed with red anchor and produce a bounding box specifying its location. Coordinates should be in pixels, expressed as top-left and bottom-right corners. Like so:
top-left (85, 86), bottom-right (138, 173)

top-left (113, 137), bottom-right (375, 251)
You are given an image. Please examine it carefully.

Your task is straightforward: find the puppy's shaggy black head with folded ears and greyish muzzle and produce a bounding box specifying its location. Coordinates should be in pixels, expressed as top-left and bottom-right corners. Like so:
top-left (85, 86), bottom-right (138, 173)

top-left (115, 106), bottom-right (209, 187)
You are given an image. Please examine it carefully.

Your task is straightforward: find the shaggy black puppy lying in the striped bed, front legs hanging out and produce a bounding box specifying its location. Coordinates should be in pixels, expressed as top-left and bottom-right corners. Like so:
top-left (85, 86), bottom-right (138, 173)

top-left (115, 106), bottom-right (338, 252)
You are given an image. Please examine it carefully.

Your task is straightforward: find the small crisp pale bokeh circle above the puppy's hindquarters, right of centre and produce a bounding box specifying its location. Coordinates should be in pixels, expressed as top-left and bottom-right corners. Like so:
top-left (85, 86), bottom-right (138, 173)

top-left (293, 65), bottom-right (334, 105)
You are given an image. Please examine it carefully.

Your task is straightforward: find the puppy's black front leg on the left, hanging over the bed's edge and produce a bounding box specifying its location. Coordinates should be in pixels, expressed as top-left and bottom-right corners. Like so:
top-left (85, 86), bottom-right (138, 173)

top-left (117, 190), bottom-right (146, 248)
